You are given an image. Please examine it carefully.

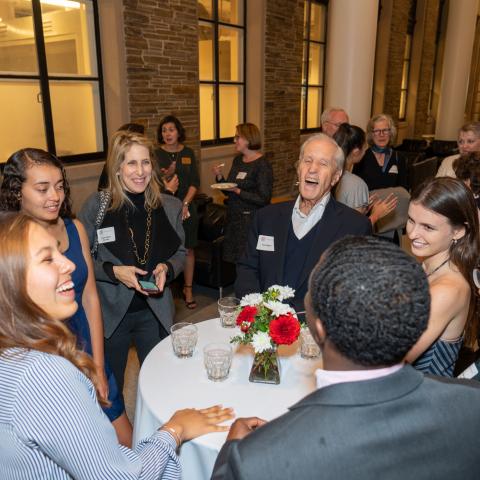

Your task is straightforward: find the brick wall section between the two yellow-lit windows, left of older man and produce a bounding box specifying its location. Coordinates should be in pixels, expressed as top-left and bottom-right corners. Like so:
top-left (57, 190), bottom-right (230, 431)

top-left (264, 0), bottom-right (304, 195)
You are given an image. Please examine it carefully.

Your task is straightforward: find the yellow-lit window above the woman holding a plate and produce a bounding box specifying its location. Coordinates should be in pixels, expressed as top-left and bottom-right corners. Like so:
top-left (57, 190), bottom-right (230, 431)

top-left (198, 0), bottom-right (245, 145)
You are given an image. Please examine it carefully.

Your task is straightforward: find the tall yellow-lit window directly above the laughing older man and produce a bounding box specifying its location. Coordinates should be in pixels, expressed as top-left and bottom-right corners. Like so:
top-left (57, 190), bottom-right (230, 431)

top-left (300, 0), bottom-right (328, 130)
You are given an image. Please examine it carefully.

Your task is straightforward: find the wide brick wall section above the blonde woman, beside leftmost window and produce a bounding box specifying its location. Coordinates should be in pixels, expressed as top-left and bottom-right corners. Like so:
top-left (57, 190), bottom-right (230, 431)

top-left (124, 0), bottom-right (200, 154)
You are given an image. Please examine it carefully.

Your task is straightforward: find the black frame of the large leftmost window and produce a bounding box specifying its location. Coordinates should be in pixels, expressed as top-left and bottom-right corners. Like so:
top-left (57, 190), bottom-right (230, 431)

top-left (0, 0), bottom-right (108, 164)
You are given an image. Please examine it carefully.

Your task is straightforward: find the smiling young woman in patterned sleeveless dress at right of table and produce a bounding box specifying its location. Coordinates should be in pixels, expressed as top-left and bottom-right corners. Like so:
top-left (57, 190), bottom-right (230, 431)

top-left (406, 177), bottom-right (480, 377)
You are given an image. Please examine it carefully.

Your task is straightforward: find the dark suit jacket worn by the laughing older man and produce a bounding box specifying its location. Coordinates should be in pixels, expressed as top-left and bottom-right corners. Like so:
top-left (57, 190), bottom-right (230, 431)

top-left (235, 196), bottom-right (372, 311)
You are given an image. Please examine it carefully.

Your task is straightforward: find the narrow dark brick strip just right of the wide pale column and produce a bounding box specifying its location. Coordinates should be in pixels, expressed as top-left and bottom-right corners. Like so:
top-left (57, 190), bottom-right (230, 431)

top-left (383, 0), bottom-right (410, 121)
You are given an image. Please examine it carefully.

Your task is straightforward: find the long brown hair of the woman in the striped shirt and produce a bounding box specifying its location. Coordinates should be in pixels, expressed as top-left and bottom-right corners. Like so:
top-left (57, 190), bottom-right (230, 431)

top-left (0, 212), bottom-right (108, 405)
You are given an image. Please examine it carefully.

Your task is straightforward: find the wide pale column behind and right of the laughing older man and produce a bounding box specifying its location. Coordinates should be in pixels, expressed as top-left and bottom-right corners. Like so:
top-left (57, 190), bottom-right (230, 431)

top-left (325, 0), bottom-right (378, 128)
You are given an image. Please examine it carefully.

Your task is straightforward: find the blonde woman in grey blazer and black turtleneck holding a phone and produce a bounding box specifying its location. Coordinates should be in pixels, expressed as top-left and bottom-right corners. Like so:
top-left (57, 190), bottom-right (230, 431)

top-left (79, 131), bottom-right (185, 398)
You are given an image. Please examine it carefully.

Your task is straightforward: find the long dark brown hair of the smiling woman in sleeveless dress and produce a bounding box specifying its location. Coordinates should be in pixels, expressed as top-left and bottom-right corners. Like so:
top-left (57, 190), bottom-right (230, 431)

top-left (411, 177), bottom-right (480, 346)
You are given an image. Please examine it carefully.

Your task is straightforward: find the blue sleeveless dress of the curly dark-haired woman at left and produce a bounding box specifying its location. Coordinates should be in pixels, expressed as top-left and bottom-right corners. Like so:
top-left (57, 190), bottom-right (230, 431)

top-left (63, 218), bottom-right (125, 422)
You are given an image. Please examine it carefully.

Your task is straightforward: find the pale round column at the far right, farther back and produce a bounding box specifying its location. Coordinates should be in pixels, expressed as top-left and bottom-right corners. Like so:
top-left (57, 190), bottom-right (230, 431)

top-left (435, 0), bottom-right (478, 140)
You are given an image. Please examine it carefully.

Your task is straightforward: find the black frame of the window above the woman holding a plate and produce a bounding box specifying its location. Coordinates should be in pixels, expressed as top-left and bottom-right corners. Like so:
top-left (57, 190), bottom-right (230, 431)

top-left (197, 0), bottom-right (247, 147)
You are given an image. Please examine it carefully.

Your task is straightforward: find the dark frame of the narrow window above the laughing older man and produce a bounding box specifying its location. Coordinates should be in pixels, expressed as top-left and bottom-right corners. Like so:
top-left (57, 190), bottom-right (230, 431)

top-left (300, 0), bottom-right (328, 134)
